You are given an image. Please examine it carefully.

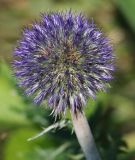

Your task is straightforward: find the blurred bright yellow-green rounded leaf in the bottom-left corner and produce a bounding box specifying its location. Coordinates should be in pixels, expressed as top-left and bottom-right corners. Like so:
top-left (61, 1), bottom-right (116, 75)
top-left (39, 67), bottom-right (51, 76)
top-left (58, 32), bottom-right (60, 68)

top-left (4, 128), bottom-right (55, 160)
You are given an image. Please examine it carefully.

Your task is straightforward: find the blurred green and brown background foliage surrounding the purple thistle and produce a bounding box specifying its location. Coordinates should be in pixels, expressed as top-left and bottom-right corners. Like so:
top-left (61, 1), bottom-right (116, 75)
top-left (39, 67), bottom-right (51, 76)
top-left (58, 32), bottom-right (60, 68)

top-left (0, 0), bottom-right (135, 160)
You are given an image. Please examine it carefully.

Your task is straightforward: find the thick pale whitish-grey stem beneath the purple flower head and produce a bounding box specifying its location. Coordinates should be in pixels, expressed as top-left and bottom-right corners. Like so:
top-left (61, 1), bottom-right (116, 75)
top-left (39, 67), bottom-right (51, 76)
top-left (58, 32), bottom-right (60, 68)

top-left (71, 112), bottom-right (101, 160)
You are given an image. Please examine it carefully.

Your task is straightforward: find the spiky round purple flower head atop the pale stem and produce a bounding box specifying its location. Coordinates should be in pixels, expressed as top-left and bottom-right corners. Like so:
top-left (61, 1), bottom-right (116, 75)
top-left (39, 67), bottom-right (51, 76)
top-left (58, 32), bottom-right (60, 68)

top-left (14, 11), bottom-right (114, 115)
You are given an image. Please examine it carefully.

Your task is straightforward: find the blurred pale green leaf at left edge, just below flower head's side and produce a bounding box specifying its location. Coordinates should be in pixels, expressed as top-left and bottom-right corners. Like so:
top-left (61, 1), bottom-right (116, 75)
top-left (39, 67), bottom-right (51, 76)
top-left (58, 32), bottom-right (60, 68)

top-left (0, 62), bottom-right (28, 127)
